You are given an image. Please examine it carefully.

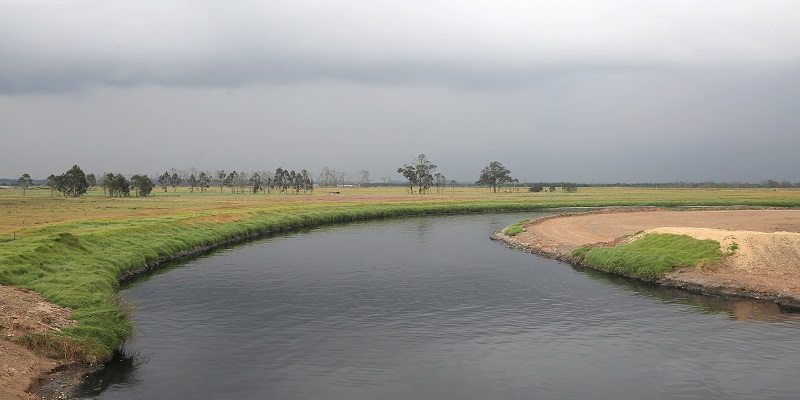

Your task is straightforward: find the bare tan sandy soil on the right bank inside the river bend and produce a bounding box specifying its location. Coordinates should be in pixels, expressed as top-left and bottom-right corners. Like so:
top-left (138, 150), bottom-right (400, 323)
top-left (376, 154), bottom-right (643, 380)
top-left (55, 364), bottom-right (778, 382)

top-left (504, 210), bottom-right (800, 307)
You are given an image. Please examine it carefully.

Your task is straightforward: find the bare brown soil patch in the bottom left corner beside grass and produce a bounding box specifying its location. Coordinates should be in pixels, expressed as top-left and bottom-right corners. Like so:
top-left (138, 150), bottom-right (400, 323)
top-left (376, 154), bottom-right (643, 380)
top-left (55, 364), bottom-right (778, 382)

top-left (0, 285), bottom-right (75, 400)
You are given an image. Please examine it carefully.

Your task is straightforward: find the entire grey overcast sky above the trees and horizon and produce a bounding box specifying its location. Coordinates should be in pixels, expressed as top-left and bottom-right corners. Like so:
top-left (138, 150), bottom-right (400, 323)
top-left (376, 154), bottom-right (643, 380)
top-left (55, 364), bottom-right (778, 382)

top-left (0, 0), bottom-right (800, 183)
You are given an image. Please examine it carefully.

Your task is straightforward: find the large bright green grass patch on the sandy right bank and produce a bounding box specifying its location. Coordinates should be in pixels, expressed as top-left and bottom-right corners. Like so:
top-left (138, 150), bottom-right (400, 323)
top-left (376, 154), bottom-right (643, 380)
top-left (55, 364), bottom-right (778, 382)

top-left (573, 234), bottom-right (723, 281)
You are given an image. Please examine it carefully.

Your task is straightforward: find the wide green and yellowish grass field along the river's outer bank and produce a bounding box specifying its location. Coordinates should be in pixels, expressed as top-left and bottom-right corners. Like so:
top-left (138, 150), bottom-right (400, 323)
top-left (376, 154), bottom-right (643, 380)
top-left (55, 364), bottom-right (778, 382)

top-left (0, 188), bottom-right (800, 361)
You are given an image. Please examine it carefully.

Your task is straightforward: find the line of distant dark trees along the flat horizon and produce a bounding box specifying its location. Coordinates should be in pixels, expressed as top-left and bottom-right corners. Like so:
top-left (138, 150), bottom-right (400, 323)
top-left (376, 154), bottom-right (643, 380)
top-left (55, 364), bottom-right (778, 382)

top-left (12, 159), bottom-right (800, 197)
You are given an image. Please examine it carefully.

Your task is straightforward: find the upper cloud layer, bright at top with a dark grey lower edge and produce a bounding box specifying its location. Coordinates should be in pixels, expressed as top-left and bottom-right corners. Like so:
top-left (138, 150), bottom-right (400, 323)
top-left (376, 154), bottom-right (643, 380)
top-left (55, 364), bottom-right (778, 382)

top-left (0, 1), bottom-right (800, 93)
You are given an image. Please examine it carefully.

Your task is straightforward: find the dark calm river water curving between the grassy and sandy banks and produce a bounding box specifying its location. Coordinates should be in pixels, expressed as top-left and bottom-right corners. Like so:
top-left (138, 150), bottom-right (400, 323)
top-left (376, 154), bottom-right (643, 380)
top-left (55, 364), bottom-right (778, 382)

top-left (76, 213), bottom-right (800, 399)
